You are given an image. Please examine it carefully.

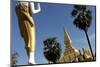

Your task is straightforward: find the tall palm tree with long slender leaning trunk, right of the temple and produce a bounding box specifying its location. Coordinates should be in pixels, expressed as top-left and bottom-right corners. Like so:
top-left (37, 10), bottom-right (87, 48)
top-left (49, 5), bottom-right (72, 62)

top-left (71, 5), bottom-right (94, 57)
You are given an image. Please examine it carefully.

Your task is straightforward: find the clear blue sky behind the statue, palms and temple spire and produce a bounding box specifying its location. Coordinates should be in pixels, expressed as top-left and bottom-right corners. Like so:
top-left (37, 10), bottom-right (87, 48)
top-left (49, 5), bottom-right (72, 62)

top-left (11, 1), bottom-right (96, 64)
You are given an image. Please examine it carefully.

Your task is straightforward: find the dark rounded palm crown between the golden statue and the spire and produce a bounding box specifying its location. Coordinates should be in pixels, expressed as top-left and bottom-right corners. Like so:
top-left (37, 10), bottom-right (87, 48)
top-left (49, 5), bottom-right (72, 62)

top-left (44, 37), bottom-right (61, 63)
